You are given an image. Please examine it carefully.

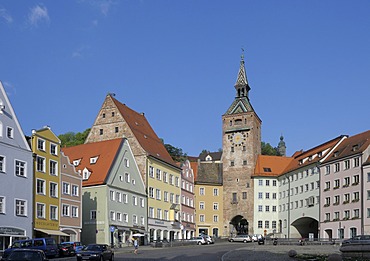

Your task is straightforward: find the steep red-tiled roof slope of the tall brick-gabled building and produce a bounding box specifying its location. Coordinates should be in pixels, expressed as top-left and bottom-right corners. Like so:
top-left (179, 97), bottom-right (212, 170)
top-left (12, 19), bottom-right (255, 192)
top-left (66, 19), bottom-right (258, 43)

top-left (111, 97), bottom-right (177, 167)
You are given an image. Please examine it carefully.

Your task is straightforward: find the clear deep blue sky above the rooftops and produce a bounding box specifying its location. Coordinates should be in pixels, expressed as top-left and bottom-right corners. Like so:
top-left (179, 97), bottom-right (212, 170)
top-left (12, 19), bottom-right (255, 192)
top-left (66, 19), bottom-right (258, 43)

top-left (0, 0), bottom-right (370, 155)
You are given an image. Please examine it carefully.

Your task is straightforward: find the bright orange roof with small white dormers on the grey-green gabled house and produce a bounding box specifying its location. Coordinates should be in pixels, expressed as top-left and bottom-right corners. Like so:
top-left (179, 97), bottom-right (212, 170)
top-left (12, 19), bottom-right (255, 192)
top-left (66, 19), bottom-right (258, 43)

top-left (62, 138), bottom-right (124, 187)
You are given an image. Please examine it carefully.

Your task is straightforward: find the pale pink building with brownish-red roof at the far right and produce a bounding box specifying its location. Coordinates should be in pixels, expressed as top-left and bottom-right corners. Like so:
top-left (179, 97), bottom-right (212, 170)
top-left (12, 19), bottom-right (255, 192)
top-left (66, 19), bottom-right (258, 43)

top-left (319, 131), bottom-right (370, 240)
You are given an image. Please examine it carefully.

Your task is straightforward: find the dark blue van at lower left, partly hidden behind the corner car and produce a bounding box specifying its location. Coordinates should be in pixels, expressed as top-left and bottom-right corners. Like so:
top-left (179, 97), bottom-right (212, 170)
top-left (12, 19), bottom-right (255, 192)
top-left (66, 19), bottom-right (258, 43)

top-left (3, 237), bottom-right (59, 258)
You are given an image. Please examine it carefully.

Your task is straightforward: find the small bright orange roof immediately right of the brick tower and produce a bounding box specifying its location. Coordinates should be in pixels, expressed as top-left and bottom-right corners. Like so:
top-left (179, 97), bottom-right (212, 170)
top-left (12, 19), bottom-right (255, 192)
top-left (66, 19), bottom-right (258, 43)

top-left (252, 155), bottom-right (293, 177)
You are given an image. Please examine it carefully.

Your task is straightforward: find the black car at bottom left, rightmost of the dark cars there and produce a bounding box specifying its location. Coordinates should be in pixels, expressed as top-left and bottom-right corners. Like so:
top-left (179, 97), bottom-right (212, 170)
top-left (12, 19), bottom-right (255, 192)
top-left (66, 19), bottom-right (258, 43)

top-left (76, 244), bottom-right (114, 261)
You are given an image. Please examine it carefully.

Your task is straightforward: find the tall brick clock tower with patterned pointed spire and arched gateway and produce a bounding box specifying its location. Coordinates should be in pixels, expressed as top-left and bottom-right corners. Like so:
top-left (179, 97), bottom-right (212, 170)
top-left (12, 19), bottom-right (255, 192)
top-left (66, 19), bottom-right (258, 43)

top-left (222, 52), bottom-right (261, 236)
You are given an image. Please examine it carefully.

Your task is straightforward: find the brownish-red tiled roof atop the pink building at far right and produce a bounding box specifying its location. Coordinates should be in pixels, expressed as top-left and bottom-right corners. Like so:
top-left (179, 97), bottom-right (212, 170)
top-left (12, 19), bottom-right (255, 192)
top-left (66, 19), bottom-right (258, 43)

top-left (325, 130), bottom-right (370, 162)
